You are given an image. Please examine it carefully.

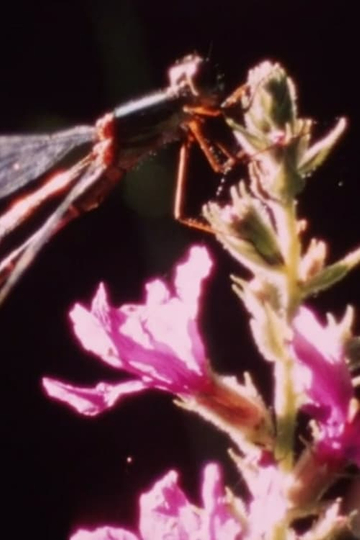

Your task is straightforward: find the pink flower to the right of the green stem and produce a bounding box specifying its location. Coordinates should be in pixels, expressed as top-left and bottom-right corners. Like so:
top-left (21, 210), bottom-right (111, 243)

top-left (292, 308), bottom-right (360, 465)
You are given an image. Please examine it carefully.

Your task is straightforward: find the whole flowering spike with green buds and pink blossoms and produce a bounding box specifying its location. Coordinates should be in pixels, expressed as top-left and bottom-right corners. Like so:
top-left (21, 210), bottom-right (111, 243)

top-left (43, 62), bottom-right (360, 540)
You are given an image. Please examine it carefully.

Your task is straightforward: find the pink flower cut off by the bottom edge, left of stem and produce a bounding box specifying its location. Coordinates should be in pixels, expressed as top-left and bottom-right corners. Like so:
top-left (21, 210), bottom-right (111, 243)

top-left (71, 464), bottom-right (242, 540)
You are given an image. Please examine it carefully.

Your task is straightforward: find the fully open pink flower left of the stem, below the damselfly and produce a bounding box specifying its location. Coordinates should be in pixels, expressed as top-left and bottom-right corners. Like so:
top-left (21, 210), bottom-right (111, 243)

top-left (43, 247), bottom-right (212, 416)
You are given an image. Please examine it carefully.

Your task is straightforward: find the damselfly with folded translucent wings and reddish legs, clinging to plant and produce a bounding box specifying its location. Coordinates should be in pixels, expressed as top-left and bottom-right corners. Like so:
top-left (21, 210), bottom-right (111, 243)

top-left (0, 55), bottom-right (242, 303)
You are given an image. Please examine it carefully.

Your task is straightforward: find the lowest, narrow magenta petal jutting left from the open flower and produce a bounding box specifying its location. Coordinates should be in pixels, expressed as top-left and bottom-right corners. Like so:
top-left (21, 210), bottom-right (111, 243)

top-left (42, 377), bottom-right (148, 416)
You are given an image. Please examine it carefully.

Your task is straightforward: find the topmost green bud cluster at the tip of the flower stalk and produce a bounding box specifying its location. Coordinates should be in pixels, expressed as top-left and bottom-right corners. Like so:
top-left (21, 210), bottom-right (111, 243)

top-left (225, 61), bottom-right (346, 203)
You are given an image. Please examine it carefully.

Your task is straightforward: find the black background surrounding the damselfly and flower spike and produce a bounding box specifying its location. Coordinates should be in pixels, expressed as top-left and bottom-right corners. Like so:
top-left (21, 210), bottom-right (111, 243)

top-left (0, 0), bottom-right (360, 540)
